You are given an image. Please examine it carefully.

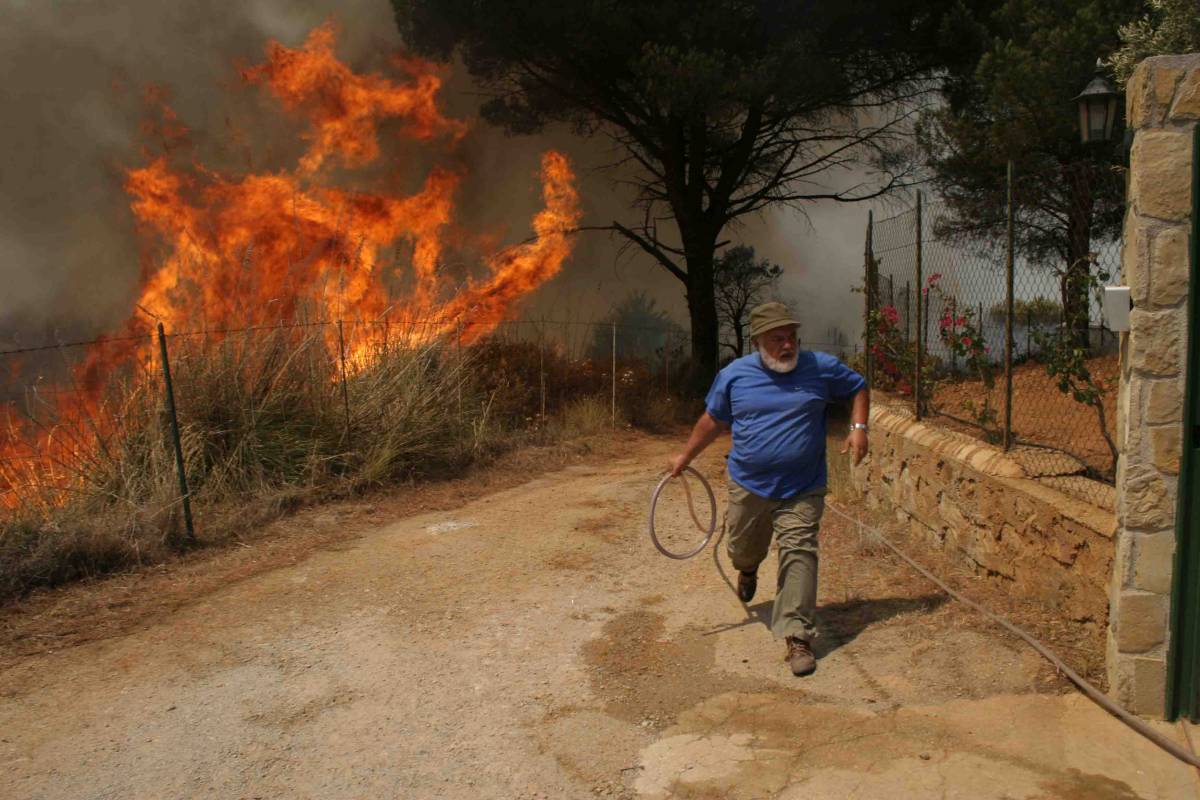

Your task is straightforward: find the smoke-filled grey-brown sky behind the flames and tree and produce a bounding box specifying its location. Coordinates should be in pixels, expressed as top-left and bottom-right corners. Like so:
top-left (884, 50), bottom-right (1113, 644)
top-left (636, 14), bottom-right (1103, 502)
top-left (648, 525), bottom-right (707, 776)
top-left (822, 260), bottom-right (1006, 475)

top-left (0, 0), bottom-right (892, 349)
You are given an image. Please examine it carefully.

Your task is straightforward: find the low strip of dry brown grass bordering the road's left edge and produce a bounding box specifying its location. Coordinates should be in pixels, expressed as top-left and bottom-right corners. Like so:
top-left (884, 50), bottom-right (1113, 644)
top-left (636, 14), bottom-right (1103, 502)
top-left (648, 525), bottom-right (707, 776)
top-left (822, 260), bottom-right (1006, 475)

top-left (0, 429), bottom-right (644, 669)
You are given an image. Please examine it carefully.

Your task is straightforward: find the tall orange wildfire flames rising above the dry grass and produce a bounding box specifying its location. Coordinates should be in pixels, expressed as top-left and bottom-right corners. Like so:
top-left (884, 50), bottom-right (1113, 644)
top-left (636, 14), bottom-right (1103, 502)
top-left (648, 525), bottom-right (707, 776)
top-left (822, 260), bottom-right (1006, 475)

top-left (0, 24), bottom-right (581, 513)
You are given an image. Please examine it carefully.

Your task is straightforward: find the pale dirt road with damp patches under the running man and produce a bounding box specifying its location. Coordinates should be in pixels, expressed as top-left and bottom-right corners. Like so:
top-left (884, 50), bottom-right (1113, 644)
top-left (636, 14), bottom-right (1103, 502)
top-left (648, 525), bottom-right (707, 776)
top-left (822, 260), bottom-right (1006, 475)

top-left (0, 439), bottom-right (1198, 800)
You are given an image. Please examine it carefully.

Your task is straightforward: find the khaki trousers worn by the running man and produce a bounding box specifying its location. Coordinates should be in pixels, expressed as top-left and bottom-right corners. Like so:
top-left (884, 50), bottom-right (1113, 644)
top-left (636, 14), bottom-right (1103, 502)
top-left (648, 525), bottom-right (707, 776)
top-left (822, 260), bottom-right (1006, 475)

top-left (725, 481), bottom-right (824, 642)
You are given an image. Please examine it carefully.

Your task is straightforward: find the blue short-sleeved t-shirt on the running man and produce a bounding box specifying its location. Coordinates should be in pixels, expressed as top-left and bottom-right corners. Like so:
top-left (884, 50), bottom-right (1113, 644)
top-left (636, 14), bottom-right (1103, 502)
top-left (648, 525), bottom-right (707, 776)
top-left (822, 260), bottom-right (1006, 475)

top-left (704, 350), bottom-right (866, 500)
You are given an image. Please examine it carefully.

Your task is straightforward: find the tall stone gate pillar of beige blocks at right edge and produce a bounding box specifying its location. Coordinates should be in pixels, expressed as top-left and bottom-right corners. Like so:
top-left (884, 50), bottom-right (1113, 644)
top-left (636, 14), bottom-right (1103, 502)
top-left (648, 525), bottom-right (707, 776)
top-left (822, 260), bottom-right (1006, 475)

top-left (1108, 54), bottom-right (1200, 716)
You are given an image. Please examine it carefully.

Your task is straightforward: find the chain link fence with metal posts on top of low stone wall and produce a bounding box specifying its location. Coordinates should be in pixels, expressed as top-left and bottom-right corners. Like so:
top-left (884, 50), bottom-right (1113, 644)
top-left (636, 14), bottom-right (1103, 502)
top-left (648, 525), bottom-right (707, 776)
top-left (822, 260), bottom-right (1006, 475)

top-left (864, 161), bottom-right (1124, 491)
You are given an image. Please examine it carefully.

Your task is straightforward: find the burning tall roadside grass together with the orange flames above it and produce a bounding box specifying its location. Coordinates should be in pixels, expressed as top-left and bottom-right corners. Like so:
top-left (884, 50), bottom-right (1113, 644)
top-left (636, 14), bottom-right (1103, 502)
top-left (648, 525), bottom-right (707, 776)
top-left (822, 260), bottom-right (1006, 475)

top-left (0, 24), bottom-right (611, 596)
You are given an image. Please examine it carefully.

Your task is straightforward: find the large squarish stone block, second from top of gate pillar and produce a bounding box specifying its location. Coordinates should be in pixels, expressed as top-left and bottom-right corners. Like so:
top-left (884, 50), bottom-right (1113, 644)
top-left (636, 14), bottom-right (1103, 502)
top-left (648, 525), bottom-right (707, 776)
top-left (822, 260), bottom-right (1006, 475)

top-left (1130, 131), bottom-right (1192, 222)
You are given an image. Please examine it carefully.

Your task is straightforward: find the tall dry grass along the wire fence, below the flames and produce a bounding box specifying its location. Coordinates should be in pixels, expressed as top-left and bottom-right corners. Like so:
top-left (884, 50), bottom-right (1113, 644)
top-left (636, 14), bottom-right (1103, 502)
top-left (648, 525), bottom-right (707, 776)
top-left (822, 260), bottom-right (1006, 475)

top-left (0, 327), bottom-right (676, 599)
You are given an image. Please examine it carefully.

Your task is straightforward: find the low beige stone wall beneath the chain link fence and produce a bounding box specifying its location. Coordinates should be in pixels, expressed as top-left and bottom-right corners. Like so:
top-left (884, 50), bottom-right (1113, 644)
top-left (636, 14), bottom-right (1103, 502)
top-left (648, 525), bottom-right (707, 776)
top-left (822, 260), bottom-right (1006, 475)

top-left (852, 403), bottom-right (1116, 626)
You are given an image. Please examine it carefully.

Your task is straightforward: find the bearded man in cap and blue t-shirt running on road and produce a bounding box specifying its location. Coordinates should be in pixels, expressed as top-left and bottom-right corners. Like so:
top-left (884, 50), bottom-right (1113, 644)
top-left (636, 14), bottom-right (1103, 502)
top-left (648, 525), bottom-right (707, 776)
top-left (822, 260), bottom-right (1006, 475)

top-left (671, 302), bottom-right (870, 675)
